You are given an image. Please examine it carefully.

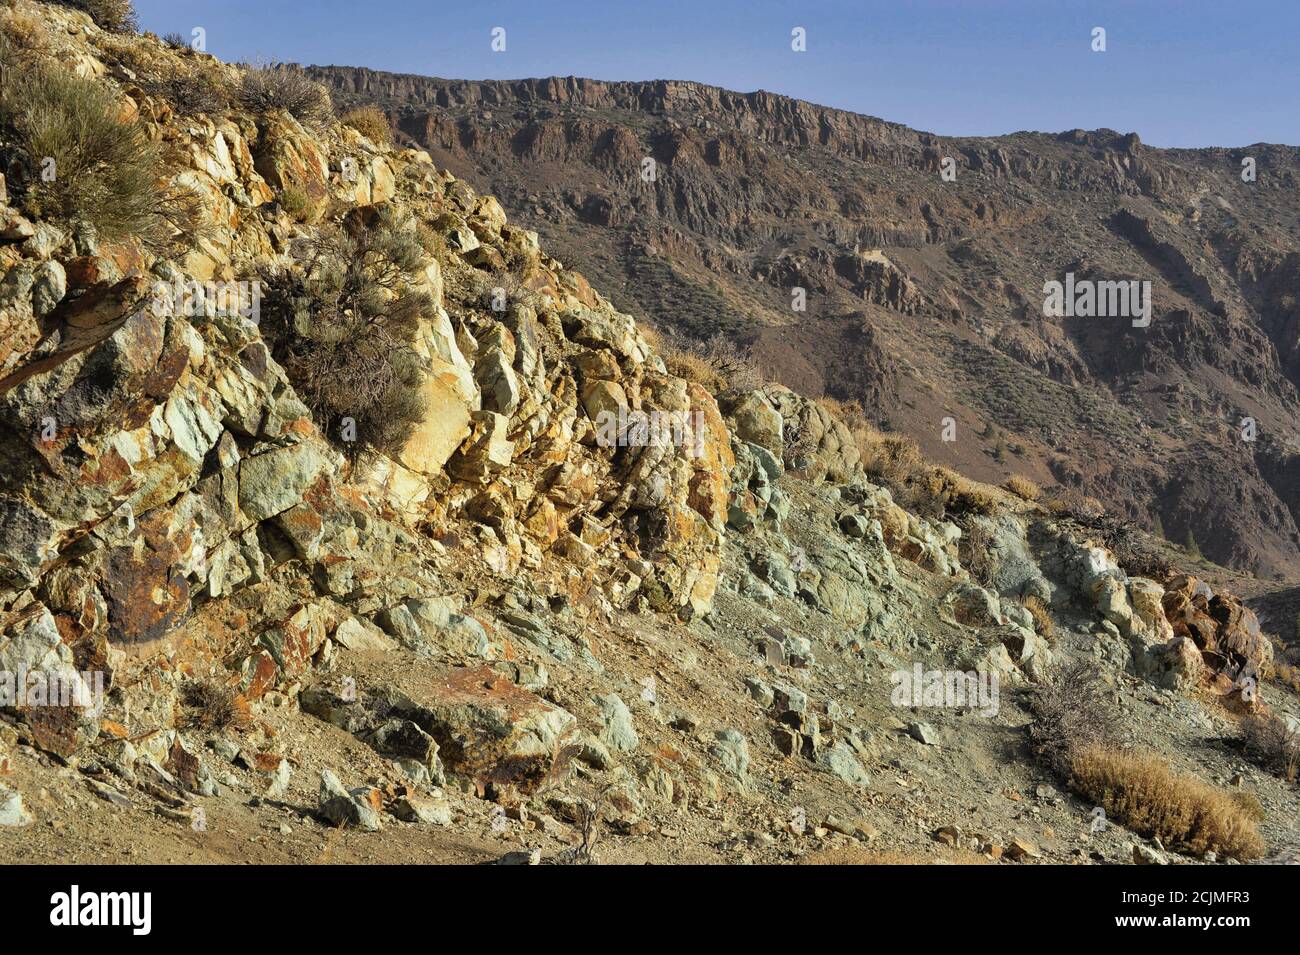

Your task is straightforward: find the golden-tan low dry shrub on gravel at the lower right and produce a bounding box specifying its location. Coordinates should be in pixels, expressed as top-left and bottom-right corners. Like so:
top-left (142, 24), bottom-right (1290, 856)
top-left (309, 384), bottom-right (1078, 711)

top-left (1070, 746), bottom-right (1264, 859)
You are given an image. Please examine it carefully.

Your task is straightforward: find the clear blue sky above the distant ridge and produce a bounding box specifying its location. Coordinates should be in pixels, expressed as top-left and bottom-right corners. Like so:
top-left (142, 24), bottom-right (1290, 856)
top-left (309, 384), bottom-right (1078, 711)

top-left (137, 0), bottom-right (1300, 146)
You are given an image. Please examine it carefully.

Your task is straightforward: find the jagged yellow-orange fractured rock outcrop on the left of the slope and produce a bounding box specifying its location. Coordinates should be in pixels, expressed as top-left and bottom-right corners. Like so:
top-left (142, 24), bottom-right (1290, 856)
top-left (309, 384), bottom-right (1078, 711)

top-left (0, 0), bottom-right (738, 773)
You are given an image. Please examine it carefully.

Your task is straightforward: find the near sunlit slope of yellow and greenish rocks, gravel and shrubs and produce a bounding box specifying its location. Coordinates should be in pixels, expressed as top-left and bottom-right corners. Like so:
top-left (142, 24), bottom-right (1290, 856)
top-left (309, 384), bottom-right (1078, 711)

top-left (0, 0), bottom-right (1300, 864)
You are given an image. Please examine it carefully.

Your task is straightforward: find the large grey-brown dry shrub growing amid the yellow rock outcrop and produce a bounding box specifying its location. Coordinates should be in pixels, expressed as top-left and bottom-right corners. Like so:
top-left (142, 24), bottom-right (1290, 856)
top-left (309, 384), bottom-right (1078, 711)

top-left (261, 210), bottom-right (433, 456)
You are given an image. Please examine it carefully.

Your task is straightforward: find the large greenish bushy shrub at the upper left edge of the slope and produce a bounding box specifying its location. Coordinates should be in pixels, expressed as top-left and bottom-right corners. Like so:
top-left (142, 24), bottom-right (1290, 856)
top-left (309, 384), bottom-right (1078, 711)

top-left (0, 55), bottom-right (200, 249)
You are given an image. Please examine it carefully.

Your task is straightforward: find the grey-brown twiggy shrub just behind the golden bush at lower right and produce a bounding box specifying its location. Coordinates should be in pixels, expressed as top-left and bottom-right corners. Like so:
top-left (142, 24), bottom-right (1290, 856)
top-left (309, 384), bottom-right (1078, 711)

top-left (1030, 661), bottom-right (1119, 778)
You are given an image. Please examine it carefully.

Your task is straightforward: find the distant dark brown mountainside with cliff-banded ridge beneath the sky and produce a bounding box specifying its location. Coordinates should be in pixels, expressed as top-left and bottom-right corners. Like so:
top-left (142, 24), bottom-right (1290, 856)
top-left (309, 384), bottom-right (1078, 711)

top-left (311, 68), bottom-right (1300, 581)
